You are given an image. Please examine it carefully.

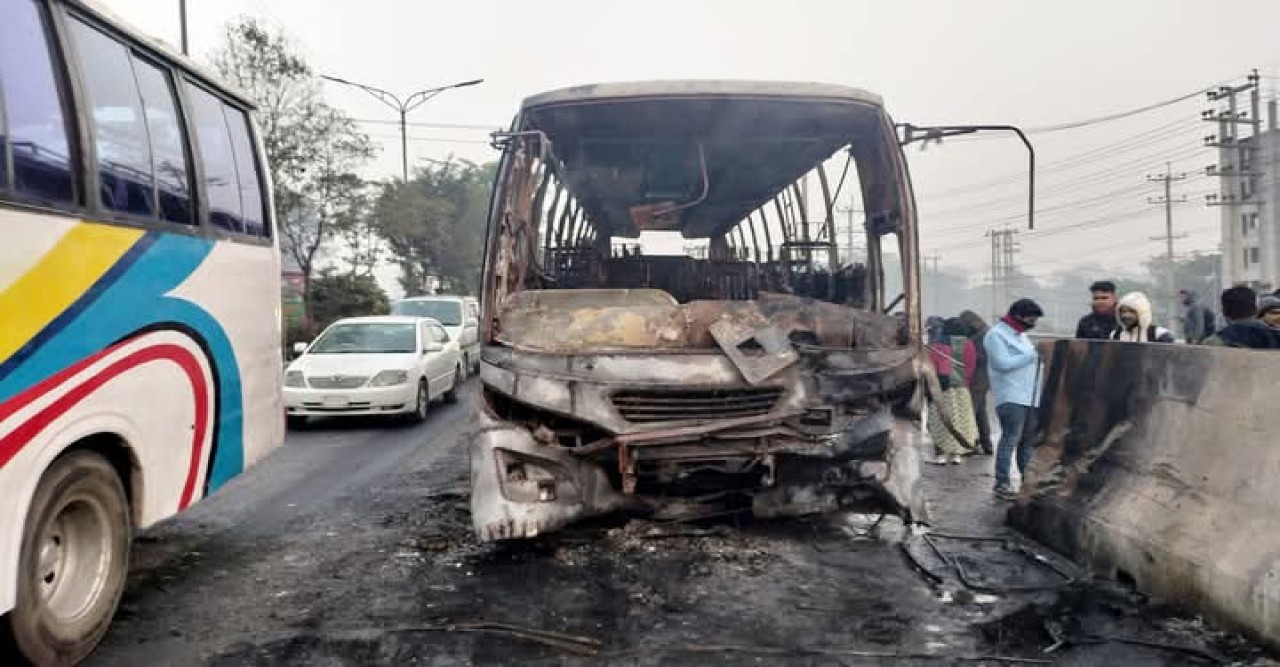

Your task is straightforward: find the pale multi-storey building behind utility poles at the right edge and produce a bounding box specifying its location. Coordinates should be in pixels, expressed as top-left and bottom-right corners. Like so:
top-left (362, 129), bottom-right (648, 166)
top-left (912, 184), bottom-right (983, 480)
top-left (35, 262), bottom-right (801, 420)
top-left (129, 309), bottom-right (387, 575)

top-left (1211, 100), bottom-right (1280, 292)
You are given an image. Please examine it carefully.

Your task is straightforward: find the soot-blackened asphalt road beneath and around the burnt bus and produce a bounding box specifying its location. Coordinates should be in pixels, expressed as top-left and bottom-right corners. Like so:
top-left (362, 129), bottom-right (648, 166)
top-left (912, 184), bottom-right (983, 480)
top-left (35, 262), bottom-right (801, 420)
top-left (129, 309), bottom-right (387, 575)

top-left (90, 385), bottom-right (1261, 666)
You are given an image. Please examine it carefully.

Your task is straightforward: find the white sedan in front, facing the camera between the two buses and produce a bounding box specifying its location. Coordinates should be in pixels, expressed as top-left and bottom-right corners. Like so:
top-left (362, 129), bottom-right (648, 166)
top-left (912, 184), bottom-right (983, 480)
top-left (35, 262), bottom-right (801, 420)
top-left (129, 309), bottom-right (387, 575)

top-left (284, 316), bottom-right (465, 426)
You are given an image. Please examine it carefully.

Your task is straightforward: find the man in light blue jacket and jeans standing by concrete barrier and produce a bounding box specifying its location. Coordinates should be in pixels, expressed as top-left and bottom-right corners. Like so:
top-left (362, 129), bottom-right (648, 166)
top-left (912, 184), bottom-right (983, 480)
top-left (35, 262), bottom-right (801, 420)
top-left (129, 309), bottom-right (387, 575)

top-left (982, 298), bottom-right (1044, 501)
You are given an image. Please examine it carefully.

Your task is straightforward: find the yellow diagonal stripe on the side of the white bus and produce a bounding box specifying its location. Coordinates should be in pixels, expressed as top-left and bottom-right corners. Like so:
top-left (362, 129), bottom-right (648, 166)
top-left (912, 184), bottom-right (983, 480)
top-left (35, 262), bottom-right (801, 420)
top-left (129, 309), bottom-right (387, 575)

top-left (0, 223), bottom-right (142, 364)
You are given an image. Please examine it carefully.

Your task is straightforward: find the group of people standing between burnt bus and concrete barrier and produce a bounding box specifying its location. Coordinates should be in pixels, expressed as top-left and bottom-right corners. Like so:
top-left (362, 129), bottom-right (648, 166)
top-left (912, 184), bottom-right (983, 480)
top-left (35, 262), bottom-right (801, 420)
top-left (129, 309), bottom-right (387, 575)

top-left (925, 298), bottom-right (1044, 499)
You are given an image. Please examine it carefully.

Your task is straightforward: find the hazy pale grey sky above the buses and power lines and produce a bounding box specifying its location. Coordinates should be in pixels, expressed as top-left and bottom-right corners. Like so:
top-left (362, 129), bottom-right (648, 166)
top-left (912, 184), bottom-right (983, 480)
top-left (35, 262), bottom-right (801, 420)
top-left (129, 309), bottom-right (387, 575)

top-left (104, 0), bottom-right (1280, 282)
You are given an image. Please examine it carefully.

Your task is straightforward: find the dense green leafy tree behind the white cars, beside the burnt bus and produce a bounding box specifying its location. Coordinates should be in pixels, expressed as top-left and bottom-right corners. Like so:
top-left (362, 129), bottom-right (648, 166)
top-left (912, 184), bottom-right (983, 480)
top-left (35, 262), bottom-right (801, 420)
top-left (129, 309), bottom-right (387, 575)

top-left (372, 159), bottom-right (497, 294)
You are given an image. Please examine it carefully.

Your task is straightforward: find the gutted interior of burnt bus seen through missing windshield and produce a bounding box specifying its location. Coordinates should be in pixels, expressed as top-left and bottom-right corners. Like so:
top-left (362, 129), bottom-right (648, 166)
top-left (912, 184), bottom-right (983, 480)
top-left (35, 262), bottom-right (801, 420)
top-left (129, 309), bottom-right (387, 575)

top-left (485, 96), bottom-right (914, 330)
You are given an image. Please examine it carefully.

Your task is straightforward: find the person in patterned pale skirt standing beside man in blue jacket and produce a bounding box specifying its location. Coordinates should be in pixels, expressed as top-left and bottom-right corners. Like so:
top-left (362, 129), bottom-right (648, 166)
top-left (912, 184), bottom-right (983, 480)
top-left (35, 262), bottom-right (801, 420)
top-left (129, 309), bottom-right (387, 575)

top-left (928, 317), bottom-right (978, 463)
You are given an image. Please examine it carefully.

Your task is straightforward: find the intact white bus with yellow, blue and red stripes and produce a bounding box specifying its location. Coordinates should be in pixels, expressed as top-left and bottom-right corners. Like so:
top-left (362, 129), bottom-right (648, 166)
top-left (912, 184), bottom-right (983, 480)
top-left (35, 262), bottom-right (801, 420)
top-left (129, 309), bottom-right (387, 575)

top-left (0, 0), bottom-right (284, 664)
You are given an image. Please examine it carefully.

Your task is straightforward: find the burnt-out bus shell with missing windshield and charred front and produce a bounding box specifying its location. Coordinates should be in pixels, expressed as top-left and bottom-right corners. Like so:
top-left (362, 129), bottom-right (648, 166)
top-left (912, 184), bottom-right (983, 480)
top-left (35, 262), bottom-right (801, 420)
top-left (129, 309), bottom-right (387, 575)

top-left (470, 82), bottom-right (942, 540)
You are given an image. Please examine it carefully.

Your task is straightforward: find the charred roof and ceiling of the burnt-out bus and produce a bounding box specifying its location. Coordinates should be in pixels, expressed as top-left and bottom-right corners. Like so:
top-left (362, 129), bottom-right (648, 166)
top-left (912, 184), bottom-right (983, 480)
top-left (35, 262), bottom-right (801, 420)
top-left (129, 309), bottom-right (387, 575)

top-left (518, 81), bottom-right (892, 238)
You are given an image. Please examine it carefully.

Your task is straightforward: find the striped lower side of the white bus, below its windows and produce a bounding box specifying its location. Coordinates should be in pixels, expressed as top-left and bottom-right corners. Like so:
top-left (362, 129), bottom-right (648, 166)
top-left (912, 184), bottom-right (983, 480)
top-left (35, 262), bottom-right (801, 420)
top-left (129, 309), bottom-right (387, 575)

top-left (0, 215), bottom-right (283, 613)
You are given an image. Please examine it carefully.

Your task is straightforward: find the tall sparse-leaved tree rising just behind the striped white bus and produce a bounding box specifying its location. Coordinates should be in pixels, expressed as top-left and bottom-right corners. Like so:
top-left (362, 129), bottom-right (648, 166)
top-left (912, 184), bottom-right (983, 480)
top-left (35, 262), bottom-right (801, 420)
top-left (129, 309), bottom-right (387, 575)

top-left (214, 17), bottom-right (374, 311)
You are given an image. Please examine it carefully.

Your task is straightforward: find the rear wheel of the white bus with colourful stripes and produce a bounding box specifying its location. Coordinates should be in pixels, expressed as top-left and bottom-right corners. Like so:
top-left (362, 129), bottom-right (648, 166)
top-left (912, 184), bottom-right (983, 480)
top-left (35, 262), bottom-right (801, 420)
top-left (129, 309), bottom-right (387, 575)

top-left (0, 451), bottom-right (132, 664)
